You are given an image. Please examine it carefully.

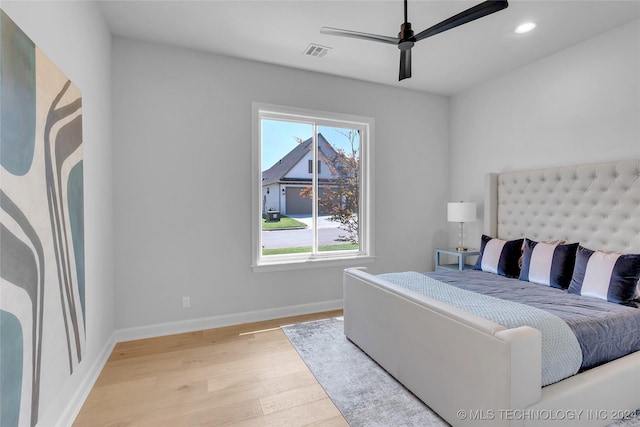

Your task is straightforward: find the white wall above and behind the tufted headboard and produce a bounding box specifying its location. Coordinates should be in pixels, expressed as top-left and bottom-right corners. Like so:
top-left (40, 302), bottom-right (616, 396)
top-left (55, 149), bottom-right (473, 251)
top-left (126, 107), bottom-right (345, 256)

top-left (448, 21), bottom-right (640, 246)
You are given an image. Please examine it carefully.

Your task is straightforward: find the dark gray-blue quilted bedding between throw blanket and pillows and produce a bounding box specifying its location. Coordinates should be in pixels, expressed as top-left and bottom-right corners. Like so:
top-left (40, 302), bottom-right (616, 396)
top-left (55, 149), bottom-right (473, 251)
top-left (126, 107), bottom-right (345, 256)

top-left (426, 270), bottom-right (640, 370)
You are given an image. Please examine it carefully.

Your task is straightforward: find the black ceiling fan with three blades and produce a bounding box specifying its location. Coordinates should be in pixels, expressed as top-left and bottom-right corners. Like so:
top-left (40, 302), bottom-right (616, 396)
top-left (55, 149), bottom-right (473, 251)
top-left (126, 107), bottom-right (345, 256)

top-left (320, 0), bottom-right (509, 81)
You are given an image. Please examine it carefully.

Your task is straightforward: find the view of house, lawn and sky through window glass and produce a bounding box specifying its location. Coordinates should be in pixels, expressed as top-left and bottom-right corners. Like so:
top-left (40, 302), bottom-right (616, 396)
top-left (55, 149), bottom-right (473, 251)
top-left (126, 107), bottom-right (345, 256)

top-left (261, 119), bottom-right (361, 256)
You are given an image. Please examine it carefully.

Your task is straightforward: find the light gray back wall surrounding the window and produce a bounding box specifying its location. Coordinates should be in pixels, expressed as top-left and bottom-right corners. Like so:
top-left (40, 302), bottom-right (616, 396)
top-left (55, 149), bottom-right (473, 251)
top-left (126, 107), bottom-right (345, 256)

top-left (113, 38), bottom-right (449, 335)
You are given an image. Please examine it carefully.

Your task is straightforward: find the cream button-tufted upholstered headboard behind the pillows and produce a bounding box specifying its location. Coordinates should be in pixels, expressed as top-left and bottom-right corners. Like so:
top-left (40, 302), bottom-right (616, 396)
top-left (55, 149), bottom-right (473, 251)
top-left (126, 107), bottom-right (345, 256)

top-left (484, 160), bottom-right (640, 253)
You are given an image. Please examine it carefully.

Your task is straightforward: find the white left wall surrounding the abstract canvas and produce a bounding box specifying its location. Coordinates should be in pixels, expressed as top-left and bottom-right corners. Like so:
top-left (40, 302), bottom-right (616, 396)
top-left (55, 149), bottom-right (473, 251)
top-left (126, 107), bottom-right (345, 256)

top-left (2, 1), bottom-right (115, 426)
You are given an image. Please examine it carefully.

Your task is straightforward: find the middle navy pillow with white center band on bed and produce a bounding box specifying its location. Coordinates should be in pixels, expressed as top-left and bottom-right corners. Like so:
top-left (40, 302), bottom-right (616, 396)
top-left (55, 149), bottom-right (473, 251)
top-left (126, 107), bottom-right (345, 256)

top-left (520, 239), bottom-right (578, 289)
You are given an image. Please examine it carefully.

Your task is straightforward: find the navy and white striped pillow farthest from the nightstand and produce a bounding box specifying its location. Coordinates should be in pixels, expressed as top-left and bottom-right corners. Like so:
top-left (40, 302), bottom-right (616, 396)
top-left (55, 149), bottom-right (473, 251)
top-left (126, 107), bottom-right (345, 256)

top-left (569, 246), bottom-right (640, 304)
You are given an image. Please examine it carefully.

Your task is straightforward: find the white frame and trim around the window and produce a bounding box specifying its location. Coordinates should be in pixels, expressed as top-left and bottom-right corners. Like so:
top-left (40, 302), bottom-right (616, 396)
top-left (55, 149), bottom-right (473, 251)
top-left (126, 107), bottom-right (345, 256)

top-left (251, 102), bottom-right (375, 272)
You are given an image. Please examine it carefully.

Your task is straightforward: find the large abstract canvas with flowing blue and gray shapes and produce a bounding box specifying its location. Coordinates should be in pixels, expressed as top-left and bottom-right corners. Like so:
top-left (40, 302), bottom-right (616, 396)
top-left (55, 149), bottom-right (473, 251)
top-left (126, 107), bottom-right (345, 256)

top-left (0, 9), bottom-right (86, 427)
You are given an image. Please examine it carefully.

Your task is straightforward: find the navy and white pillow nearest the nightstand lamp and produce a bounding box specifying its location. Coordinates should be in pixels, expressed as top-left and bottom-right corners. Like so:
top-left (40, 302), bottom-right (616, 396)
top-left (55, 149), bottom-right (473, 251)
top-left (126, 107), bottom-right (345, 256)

top-left (474, 235), bottom-right (524, 278)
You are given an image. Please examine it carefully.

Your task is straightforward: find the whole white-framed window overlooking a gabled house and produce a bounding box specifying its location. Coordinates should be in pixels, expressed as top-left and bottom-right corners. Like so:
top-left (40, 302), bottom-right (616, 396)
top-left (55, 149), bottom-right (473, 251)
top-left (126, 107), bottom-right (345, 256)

top-left (252, 103), bottom-right (373, 271)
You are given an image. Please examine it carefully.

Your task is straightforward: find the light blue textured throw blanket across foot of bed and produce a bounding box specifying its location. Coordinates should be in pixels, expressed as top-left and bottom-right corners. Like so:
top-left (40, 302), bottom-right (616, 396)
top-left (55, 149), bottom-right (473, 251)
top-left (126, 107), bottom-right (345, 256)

top-left (378, 272), bottom-right (582, 386)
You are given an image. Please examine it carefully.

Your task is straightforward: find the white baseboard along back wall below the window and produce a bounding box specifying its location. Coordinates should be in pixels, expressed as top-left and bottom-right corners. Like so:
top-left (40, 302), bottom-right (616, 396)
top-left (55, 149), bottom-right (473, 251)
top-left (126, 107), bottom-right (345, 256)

top-left (114, 299), bottom-right (343, 342)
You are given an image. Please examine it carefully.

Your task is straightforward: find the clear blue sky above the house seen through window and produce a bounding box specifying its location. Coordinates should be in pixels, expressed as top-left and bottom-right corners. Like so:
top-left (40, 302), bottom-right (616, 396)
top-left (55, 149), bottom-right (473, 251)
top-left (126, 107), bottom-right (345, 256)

top-left (262, 120), bottom-right (359, 171)
